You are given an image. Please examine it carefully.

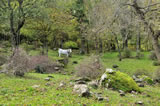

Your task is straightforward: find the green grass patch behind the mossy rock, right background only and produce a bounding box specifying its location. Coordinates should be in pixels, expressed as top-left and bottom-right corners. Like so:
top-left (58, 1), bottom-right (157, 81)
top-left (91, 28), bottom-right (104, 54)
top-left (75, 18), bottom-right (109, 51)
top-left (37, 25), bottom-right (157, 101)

top-left (102, 52), bottom-right (158, 75)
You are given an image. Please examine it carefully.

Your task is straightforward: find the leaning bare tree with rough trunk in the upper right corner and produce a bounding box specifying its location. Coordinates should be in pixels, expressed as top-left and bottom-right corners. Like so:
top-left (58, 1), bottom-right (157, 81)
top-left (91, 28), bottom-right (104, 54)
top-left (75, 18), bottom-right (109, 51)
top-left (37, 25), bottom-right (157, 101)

top-left (127, 0), bottom-right (160, 61)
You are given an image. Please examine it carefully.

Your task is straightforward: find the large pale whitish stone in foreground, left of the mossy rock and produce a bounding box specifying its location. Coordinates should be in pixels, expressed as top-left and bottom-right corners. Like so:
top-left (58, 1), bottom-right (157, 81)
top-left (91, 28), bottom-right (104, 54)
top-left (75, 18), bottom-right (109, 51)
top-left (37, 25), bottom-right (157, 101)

top-left (73, 84), bottom-right (91, 97)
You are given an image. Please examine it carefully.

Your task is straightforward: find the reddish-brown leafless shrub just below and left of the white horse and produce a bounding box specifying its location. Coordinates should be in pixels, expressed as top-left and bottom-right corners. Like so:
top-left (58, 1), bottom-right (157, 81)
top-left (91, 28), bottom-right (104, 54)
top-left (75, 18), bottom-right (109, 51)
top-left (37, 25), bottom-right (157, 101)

top-left (30, 56), bottom-right (62, 73)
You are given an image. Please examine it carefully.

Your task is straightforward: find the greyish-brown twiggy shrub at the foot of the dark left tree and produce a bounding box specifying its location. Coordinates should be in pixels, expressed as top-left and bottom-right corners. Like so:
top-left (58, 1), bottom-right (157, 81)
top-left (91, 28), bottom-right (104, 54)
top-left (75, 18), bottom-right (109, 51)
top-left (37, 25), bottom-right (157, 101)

top-left (6, 48), bottom-right (30, 76)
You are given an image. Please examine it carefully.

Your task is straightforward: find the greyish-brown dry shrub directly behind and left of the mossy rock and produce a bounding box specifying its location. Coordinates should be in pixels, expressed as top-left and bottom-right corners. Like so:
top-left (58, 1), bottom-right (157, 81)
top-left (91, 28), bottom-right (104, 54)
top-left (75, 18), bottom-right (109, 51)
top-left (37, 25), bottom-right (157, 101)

top-left (75, 55), bottom-right (104, 79)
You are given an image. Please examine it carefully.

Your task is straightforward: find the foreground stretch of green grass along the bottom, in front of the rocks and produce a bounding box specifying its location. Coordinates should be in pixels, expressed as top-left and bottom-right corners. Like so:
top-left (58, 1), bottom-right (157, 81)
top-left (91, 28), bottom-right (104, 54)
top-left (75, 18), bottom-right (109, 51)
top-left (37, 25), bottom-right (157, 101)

top-left (0, 73), bottom-right (160, 106)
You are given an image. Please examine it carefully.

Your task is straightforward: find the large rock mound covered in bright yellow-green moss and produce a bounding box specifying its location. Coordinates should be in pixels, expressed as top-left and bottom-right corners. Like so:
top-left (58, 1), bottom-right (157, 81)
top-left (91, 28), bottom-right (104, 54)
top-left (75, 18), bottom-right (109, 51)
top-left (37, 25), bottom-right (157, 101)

top-left (103, 71), bottom-right (141, 92)
